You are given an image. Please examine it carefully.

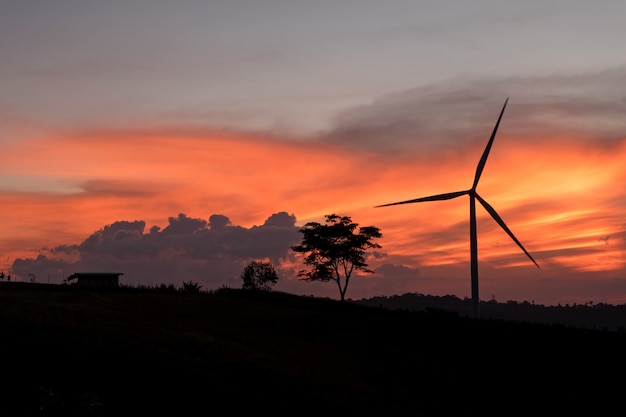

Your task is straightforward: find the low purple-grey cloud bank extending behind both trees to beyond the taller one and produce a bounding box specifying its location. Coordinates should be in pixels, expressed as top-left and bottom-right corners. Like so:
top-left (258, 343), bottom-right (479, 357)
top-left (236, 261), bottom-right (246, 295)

top-left (11, 211), bottom-right (419, 299)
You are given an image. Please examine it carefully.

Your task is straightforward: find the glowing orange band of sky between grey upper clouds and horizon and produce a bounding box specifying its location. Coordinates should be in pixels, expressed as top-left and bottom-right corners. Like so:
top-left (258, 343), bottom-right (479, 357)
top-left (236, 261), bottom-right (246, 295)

top-left (0, 117), bottom-right (626, 304)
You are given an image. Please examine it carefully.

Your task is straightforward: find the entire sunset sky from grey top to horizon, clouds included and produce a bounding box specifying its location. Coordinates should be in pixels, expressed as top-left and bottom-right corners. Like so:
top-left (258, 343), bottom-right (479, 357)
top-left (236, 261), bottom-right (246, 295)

top-left (0, 0), bottom-right (626, 305)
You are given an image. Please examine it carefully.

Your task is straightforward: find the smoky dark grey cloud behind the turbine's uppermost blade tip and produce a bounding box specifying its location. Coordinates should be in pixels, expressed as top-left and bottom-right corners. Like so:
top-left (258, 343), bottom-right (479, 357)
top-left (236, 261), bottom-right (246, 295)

top-left (324, 67), bottom-right (626, 151)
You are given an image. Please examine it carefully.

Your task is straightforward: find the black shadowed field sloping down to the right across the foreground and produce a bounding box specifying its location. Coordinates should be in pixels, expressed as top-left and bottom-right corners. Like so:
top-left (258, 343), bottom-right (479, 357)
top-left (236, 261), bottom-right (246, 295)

top-left (0, 283), bottom-right (626, 416)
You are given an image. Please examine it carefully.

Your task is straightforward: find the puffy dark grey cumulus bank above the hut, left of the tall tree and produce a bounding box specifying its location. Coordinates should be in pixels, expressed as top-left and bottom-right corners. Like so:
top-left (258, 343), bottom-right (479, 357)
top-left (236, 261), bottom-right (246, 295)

top-left (12, 212), bottom-right (300, 289)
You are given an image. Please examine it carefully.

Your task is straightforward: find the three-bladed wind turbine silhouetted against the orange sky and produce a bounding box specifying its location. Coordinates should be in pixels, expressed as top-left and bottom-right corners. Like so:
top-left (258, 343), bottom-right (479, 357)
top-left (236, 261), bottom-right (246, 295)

top-left (375, 98), bottom-right (539, 318)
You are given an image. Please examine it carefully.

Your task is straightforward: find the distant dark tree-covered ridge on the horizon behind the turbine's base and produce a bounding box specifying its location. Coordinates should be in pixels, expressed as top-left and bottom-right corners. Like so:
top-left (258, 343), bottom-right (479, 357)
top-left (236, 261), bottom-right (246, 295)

top-left (357, 293), bottom-right (626, 331)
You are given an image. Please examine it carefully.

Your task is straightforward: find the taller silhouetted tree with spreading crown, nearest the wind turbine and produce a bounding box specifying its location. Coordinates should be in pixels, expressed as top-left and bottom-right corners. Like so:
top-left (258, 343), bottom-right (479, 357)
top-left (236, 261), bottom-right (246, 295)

top-left (291, 214), bottom-right (382, 301)
